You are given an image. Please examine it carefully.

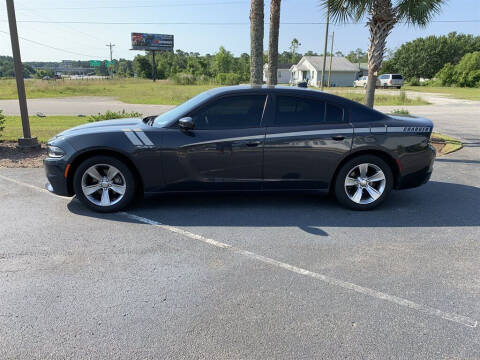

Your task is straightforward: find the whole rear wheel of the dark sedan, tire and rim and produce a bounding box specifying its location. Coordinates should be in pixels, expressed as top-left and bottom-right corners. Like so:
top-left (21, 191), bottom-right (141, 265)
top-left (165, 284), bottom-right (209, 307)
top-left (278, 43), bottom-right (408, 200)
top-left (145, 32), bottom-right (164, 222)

top-left (335, 155), bottom-right (393, 210)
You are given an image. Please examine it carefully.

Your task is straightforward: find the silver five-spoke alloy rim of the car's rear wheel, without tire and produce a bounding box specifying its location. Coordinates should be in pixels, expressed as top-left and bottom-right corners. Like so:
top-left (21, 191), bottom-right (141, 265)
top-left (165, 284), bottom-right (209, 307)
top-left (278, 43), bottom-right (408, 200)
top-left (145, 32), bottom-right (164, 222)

top-left (345, 163), bottom-right (386, 204)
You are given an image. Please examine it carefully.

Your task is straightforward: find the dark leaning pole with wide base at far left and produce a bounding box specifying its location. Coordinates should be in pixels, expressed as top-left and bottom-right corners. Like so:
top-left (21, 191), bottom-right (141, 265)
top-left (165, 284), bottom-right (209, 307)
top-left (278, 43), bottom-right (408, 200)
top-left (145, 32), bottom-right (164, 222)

top-left (7, 0), bottom-right (40, 149)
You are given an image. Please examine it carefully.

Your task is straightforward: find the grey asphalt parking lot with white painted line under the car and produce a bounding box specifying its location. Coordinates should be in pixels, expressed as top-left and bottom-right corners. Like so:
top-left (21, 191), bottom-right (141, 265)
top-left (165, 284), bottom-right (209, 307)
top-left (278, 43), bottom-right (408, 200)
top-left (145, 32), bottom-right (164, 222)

top-left (0, 105), bottom-right (480, 359)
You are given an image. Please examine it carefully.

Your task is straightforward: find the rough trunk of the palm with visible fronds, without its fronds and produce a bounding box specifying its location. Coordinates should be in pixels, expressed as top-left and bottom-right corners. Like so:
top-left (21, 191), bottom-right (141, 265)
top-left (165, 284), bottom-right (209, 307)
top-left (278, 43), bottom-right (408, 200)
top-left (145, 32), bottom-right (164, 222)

top-left (365, 0), bottom-right (396, 108)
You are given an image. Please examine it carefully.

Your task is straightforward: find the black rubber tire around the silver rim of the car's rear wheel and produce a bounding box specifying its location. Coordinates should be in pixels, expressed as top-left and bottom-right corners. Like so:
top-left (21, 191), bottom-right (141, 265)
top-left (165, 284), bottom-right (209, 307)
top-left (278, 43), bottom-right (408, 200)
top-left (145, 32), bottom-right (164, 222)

top-left (334, 155), bottom-right (393, 210)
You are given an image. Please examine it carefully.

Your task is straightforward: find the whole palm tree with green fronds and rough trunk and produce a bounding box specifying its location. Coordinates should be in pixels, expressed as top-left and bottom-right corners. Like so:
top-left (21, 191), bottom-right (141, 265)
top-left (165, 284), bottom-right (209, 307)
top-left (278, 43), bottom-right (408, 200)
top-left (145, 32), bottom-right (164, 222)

top-left (321, 0), bottom-right (446, 107)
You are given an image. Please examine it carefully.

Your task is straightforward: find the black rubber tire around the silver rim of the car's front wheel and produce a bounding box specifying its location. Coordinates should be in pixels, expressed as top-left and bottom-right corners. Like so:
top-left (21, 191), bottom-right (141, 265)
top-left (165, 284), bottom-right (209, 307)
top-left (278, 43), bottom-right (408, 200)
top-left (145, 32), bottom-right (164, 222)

top-left (73, 155), bottom-right (136, 213)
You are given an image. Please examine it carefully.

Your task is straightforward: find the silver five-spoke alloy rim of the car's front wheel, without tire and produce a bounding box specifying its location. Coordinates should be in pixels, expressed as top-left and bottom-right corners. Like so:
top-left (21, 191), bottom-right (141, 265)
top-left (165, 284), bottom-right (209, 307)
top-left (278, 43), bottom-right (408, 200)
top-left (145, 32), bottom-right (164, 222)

top-left (81, 164), bottom-right (127, 206)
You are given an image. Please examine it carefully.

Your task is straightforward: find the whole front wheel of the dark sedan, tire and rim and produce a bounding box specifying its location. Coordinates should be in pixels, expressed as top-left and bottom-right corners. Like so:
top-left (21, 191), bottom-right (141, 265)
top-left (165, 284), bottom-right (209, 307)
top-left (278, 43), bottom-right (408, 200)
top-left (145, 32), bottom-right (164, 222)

top-left (73, 156), bottom-right (136, 212)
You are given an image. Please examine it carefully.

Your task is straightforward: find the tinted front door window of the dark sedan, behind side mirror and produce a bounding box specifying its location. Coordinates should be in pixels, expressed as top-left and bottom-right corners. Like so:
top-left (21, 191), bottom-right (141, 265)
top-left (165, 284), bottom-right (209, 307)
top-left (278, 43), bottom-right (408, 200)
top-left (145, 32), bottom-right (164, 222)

top-left (192, 95), bottom-right (266, 130)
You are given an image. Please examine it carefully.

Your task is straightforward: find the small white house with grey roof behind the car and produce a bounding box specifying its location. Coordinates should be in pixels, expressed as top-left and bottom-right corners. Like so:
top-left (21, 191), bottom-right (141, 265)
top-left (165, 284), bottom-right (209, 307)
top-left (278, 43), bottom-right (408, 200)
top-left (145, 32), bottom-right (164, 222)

top-left (290, 56), bottom-right (359, 86)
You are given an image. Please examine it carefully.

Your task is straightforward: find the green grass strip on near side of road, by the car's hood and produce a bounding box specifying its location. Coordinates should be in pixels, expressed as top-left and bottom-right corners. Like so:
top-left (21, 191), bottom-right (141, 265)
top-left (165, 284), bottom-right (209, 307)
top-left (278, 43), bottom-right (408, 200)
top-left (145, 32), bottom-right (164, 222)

top-left (0, 116), bottom-right (88, 143)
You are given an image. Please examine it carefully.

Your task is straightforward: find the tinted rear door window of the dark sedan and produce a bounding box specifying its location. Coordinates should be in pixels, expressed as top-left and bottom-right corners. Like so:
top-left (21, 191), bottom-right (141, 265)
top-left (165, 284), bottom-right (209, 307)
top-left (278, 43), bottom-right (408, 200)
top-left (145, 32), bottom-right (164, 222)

top-left (274, 96), bottom-right (325, 126)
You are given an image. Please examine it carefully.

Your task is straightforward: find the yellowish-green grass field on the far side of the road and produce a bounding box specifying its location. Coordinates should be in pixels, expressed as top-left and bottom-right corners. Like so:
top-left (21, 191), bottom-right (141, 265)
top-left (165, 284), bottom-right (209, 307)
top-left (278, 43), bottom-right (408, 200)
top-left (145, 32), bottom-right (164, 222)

top-left (0, 79), bottom-right (428, 105)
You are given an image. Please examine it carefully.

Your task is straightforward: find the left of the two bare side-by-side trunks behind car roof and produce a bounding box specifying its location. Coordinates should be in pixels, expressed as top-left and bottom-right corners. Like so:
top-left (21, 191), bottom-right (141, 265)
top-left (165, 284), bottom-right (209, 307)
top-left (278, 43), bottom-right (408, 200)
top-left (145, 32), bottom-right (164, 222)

top-left (250, 0), bottom-right (264, 85)
